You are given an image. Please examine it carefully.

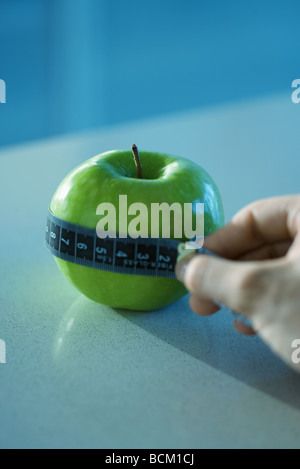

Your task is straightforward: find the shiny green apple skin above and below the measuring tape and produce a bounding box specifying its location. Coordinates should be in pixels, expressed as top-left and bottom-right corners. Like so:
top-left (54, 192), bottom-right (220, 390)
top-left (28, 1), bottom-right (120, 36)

top-left (50, 150), bottom-right (224, 311)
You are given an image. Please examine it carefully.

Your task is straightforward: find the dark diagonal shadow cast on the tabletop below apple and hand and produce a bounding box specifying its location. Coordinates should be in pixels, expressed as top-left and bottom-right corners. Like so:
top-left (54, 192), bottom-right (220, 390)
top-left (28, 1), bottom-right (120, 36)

top-left (118, 297), bottom-right (300, 409)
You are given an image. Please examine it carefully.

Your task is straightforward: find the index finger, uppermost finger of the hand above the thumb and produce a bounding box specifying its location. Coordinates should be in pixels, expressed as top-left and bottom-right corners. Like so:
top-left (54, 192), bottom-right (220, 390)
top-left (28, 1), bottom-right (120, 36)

top-left (204, 195), bottom-right (300, 259)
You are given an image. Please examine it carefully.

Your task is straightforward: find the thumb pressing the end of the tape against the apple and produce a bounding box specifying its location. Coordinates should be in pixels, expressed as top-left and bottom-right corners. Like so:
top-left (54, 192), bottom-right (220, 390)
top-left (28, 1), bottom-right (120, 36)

top-left (176, 254), bottom-right (269, 315)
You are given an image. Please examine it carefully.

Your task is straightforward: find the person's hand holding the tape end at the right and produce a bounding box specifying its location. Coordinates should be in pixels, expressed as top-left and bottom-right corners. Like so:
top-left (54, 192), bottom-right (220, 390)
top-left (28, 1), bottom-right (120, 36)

top-left (176, 195), bottom-right (300, 371)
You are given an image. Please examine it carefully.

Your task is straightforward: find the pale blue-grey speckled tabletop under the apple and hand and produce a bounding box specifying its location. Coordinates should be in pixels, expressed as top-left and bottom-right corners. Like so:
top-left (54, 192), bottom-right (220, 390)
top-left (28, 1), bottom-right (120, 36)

top-left (0, 93), bottom-right (300, 449)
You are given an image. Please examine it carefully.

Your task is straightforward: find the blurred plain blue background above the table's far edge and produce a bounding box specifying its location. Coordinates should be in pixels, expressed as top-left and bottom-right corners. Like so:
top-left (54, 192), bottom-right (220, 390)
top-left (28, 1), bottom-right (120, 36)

top-left (0, 0), bottom-right (300, 145)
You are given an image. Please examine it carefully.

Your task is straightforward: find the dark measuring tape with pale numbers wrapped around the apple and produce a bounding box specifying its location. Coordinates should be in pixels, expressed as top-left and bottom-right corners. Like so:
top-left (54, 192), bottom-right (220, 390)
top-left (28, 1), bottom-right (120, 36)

top-left (45, 210), bottom-right (251, 325)
